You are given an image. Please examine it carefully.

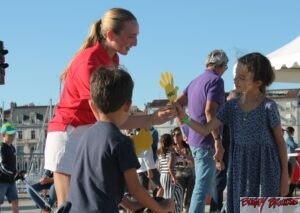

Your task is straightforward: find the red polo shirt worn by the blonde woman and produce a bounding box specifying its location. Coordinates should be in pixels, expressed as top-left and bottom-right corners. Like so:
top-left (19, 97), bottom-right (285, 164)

top-left (48, 43), bottom-right (119, 132)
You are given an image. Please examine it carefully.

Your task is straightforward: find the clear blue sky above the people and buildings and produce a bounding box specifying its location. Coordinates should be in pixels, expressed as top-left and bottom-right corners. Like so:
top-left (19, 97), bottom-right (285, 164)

top-left (0, 0), bottom-right (300, 109)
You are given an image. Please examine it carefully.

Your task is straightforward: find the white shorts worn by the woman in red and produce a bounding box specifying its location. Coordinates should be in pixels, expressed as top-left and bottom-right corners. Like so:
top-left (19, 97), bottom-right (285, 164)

top-left (45, 124), bottom-right (91, 175)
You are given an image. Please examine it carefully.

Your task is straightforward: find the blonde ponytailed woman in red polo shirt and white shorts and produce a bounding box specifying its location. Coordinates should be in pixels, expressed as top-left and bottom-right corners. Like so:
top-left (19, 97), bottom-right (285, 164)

top-left (45, 8), bottom-right (175, 206)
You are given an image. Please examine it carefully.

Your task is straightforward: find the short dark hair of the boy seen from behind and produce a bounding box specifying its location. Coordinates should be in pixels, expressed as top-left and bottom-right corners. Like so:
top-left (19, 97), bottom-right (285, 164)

top-left (91, 67), bottom-right (134, 114)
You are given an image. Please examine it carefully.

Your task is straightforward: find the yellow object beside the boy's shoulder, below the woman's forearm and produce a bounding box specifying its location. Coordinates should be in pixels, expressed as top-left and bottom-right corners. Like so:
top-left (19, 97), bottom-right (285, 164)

top-left (131, 129), bottom-right (153, 156)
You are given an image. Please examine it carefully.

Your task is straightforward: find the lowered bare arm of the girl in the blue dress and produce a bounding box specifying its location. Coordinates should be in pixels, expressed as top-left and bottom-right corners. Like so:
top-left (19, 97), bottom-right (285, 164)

top-left (273, 124), bottom-right (289, 196)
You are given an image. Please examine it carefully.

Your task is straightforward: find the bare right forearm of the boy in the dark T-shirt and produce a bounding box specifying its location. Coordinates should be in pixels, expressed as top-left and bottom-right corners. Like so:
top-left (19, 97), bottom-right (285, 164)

top-left (124, 168), bottom-right (174, 212)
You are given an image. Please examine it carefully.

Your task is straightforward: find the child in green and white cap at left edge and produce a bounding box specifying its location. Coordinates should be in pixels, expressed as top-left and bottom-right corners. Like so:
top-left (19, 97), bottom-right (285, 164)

top-left (0, 122), bottom-right (19, 213)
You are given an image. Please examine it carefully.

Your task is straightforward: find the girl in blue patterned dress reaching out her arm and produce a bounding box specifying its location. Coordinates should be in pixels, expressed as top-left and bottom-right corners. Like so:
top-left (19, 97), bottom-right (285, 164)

top-left (177, 53), bottom-right (289, 213)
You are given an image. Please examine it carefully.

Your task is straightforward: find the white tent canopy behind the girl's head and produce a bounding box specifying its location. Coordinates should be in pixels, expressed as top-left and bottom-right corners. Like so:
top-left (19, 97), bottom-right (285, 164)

top-left (267, 36), bottom-right (300, 83)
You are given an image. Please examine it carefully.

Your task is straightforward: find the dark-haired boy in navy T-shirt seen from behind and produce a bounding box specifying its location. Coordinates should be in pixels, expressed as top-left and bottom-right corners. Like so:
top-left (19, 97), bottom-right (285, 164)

top-left (69, 68), bottom-right (174, 213)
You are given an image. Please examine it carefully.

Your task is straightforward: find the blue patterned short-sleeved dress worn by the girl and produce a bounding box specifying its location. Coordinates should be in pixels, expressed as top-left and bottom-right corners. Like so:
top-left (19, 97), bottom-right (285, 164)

top-left (217, 98), bottom-right (281, 213)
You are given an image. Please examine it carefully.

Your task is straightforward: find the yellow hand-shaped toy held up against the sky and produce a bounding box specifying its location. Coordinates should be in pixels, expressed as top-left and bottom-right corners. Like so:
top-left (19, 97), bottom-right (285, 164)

top-left (159, 72), bottom-right (178, 103)
